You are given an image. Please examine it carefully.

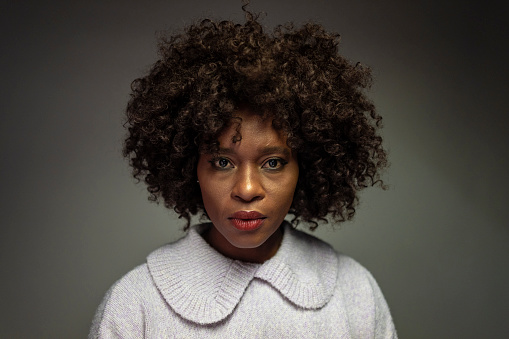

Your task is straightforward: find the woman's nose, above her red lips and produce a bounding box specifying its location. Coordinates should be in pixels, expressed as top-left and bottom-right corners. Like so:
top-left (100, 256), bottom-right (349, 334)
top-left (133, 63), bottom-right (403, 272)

top-left (231, 167), bottom-right (265, 202)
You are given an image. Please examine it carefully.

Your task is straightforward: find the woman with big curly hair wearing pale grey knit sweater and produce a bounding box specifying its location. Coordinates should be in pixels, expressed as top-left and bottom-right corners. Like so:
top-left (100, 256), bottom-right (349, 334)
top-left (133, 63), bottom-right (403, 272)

top-left (90, 6), bottom-right (396, 338)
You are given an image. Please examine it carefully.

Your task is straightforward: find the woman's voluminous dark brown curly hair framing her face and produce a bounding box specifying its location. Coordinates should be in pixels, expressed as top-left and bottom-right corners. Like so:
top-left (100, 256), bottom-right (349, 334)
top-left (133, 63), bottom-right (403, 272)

top-left (123, 8), bottom-right (387, 229)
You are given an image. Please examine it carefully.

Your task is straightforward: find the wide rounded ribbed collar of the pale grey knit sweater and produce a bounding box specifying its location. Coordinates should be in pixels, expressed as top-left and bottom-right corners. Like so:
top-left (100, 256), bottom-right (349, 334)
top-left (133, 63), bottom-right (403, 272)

top-left (147, 222), bottom-right (338, 324)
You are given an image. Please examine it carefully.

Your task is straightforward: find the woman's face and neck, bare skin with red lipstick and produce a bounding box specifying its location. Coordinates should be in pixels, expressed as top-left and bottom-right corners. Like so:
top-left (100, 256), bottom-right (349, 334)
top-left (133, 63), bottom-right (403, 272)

top-left (197, 108), bottom-right (299, 262)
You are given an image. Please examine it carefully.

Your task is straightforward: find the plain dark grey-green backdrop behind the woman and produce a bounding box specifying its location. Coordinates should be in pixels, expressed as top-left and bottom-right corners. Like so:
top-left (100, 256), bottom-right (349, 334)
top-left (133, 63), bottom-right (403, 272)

top-left (0, 0), bottom-right (509, 338)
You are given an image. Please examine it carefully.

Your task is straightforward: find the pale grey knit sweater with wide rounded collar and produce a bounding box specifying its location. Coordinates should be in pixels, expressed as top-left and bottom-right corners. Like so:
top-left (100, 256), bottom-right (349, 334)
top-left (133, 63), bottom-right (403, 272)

top-left (89, 222), bottom-right (397, 338)
